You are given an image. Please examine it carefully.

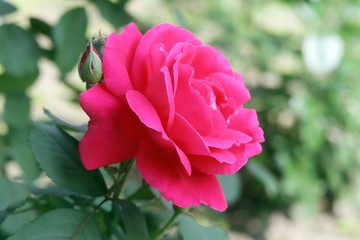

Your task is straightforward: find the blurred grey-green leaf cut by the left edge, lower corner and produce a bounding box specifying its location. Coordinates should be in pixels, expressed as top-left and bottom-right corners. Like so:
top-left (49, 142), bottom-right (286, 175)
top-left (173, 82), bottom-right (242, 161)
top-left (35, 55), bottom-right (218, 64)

top-left (0, 176), bottom-right (29, 210)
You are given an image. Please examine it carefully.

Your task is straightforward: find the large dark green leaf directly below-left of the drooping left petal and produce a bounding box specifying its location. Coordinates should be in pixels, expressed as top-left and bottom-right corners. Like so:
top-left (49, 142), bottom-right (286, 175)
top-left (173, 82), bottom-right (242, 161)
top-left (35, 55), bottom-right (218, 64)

top-left (30, 122), bottom-right (107, 196)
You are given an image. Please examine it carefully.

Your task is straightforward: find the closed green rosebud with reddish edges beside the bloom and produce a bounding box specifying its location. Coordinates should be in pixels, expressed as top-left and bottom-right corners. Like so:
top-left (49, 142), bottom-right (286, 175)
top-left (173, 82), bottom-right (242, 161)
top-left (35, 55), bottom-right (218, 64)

top-left (78, 33), bottom-right (106, 88)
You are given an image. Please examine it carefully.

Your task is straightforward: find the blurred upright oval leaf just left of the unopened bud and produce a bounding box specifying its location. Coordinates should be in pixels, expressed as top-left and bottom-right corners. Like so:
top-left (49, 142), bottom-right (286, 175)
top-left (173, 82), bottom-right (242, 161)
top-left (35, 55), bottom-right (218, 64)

top-left (53, 8), bottom-right (87, 75)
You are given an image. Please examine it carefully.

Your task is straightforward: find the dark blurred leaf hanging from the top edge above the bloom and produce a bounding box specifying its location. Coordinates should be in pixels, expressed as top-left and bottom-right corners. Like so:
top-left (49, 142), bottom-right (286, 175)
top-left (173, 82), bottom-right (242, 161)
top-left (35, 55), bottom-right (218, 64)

top-left (90, 0), bottom-right (132, 28)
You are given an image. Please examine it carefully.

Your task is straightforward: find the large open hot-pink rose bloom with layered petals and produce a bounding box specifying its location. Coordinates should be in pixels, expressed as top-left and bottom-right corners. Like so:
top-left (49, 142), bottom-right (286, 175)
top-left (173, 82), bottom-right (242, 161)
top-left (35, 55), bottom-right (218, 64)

top-left (79, 24), bottom-right (264, 211)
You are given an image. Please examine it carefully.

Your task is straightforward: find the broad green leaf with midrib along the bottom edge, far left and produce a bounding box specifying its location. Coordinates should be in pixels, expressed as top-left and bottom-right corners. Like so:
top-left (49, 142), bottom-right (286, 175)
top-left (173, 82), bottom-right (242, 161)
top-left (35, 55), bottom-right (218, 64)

top-left (8, 209), bottom-right (102, 240)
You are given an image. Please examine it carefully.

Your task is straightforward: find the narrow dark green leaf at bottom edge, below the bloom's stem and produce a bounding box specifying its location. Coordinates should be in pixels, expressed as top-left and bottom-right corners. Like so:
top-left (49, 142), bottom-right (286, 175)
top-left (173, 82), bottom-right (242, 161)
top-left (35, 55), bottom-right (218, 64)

top-left (113, 199), bottom-right (149, 240)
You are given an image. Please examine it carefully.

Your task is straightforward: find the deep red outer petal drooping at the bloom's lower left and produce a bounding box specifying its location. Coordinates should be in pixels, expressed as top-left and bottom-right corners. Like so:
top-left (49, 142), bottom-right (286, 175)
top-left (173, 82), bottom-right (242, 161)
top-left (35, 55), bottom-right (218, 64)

top-left (79, 84), bottom-right (142, 170)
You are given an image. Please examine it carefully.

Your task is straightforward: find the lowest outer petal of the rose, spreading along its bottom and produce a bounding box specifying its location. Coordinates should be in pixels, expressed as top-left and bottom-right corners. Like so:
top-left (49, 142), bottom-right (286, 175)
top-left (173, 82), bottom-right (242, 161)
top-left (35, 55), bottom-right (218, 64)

top-left (136, 141), bottom-right (227, 211)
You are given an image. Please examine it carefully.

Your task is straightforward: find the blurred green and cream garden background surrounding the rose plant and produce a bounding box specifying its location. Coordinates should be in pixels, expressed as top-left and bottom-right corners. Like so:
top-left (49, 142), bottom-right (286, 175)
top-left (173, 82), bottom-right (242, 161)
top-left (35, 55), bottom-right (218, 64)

top-left (0, 0), bottom-right (360, 240)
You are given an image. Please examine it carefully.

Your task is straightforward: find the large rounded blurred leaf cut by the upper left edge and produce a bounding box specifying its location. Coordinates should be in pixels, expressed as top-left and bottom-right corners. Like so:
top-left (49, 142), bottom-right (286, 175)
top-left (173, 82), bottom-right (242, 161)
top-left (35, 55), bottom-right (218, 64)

top-left (0, 24), bottom-right (40, 78)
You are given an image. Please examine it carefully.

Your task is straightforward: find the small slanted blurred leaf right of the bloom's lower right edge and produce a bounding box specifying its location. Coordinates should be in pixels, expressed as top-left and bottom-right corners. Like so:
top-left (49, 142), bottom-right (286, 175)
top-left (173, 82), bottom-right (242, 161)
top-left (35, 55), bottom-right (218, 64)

top-left (246, 161), bottom-right (278, 194)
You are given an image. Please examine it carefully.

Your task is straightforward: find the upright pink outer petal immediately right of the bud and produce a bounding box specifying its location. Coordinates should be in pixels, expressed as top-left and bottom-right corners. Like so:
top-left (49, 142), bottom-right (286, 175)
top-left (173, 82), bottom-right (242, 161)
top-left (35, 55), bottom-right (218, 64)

top-left (103, 24), bottom-right (142, 96)
